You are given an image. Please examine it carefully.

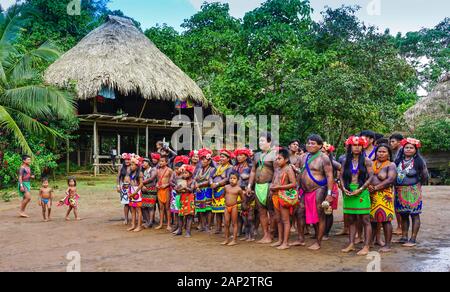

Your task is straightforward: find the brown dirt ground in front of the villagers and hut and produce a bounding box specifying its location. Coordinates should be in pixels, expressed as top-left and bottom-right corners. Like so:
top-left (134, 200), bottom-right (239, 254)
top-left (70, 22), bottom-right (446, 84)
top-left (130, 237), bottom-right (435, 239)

top-left (0, 177), bottom-right (450, 272)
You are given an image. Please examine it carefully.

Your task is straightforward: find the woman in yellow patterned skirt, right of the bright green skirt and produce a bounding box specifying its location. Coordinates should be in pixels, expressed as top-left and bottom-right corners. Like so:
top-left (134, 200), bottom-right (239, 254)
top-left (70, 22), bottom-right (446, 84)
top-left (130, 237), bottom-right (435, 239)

top-left (368, 144), bottom-right (397, 252)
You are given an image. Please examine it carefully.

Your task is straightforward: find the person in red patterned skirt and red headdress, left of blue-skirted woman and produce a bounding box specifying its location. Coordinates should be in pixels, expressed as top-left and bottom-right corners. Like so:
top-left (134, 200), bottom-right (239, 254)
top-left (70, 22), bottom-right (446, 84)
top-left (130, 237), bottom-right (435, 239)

top-left (176, 165), bottom-right (195, 238)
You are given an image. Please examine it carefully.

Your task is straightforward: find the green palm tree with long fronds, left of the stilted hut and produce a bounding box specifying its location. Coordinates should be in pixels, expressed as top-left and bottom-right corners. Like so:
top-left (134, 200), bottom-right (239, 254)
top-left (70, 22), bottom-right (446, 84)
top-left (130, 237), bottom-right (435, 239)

top-left (0, 5), bottom-right (75, 156)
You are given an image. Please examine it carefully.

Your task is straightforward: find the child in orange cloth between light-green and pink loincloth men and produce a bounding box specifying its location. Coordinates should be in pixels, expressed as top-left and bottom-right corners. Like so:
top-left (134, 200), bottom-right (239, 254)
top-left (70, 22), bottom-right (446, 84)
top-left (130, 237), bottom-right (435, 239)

top-left (270, 149), bottom-right (298, 249)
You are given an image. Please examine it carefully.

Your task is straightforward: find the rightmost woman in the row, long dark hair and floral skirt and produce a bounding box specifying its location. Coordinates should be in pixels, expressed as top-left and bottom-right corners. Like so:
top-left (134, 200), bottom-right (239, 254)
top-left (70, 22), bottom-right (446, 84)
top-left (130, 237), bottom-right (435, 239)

top-left (395, 138), bottom-right (428, 247)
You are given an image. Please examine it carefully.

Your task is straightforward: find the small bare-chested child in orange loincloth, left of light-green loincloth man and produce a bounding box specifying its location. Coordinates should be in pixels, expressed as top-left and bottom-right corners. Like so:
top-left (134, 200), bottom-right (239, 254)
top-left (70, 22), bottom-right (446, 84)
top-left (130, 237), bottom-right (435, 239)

top-left (222, 171), bottom-right (244, 246)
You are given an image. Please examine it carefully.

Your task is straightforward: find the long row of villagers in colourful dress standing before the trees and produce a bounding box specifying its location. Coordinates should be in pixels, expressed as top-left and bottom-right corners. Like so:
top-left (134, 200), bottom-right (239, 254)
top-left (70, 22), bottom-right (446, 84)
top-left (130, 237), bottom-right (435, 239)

top-left (117, 131), bottom-right (428, 255)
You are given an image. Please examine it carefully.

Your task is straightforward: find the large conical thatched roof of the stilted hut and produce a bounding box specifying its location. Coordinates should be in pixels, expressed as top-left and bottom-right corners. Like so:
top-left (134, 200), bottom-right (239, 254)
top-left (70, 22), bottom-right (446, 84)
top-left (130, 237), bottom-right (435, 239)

top-left (45, 16), bottom-right (210, 106)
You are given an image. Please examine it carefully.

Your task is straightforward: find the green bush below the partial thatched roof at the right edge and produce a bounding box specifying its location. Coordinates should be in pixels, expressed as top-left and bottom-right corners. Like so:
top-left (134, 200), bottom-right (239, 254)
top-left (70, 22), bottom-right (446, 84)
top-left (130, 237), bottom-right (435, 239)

top-left (414, 118), bottom-right (450, 152)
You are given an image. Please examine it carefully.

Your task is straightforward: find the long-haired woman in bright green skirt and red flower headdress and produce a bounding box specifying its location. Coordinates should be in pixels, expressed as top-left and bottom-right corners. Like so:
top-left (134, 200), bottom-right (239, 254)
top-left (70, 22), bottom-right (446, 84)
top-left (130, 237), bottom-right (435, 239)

top-left (340, 136), bottom-right (373, 256)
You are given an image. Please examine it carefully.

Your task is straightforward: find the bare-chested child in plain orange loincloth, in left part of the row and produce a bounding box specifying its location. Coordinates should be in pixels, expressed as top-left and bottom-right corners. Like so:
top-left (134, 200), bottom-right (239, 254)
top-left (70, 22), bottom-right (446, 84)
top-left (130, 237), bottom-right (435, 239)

top-left (155, 156), bottom-right (173, 231)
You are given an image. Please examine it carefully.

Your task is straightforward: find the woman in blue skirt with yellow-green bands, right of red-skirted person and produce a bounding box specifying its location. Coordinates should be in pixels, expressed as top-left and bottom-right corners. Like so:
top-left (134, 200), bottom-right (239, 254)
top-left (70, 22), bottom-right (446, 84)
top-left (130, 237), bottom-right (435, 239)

top-left (194, 149), bottom-right (216, 232)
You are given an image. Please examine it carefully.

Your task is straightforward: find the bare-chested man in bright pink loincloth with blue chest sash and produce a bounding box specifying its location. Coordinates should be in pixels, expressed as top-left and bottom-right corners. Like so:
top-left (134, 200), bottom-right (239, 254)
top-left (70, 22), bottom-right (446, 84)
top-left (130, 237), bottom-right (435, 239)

top-left (299, 134), bottom-right (334, 250)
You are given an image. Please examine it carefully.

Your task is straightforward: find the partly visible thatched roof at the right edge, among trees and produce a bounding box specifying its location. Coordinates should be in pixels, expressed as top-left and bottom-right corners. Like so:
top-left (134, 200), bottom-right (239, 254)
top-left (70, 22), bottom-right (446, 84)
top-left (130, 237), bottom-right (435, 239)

top-left (405, 73), bottom-right (450, 129)
